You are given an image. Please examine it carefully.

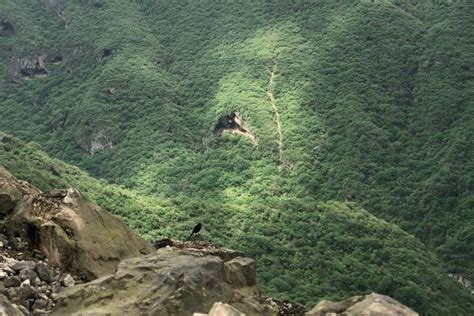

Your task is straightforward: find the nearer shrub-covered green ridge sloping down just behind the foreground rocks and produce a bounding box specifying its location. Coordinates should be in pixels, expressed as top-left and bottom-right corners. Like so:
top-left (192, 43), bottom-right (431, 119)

top-left (0, 134), bottom-right (474, 315)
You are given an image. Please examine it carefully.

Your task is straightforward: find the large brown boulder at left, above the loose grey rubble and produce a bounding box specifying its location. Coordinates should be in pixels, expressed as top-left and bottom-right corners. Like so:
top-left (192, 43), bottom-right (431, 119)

top-left (8, 189), bottom-right (152, 280)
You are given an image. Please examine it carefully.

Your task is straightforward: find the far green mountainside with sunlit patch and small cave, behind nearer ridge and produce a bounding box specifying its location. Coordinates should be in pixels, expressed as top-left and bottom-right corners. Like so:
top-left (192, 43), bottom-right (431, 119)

top-left (0, 0), bottom-right (474, 278)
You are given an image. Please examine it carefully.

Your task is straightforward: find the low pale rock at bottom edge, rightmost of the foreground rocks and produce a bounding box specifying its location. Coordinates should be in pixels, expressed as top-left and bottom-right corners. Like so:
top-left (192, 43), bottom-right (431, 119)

top-left (305, 293), bottom-right (418, 316)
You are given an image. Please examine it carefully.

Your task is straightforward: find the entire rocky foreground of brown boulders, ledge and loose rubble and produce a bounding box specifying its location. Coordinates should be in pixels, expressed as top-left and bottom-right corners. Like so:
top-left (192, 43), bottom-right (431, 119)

top-left (0, 167), bottom-right (416, 316)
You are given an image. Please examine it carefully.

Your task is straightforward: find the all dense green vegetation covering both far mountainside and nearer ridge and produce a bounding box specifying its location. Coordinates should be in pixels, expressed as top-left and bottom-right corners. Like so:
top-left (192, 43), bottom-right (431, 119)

top-left (0, 0), bottom-right (474, 314)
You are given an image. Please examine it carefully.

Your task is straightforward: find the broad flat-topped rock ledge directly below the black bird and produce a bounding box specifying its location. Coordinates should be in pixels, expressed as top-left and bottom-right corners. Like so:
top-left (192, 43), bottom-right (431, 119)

top-left (53, 247), bottom-right (272, 316)
